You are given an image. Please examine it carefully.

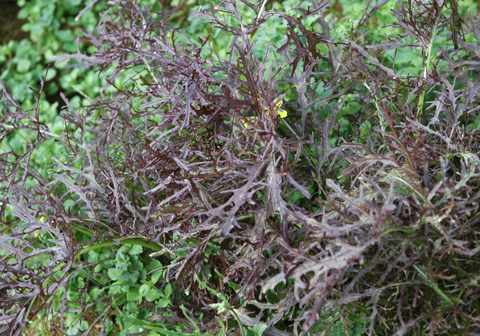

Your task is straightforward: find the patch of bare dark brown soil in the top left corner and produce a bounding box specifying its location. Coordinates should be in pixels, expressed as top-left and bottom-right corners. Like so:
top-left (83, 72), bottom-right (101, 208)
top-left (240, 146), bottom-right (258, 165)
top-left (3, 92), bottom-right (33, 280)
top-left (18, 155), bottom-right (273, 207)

top-left (0, 1), bottom-right (30, 44)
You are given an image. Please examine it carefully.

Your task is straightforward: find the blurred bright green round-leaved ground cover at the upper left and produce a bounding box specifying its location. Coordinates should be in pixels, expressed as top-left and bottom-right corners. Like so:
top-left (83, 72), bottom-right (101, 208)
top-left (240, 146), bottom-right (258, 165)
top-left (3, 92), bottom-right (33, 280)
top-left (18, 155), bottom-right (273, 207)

top-left (0, 0), bottom-right (105, 194)
